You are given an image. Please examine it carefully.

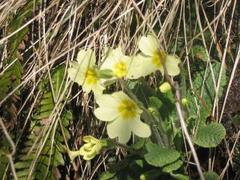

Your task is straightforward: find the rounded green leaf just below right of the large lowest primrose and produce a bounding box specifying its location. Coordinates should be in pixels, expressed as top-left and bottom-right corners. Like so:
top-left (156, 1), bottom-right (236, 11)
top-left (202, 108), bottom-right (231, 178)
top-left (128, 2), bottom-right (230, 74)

top-left (144, 143), bottom-right (180, 167)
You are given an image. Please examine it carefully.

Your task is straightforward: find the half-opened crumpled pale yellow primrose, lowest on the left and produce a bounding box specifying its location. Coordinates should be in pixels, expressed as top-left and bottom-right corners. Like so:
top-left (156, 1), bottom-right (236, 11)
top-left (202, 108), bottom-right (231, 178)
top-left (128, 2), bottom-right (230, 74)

top-left (68, 136), bottom-right (107, 161)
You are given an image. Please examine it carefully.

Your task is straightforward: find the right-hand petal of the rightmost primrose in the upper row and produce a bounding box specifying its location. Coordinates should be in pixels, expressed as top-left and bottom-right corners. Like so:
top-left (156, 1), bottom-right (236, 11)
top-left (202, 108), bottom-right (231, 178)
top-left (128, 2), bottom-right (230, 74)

top-left (165, 55), bottom-right (180, 76)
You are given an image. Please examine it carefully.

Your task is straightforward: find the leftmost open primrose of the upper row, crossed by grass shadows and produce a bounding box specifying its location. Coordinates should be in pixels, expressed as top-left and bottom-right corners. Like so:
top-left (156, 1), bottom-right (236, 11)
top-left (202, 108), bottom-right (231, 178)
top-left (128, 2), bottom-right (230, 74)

top-left (68, 49), bottom-right (104, 95)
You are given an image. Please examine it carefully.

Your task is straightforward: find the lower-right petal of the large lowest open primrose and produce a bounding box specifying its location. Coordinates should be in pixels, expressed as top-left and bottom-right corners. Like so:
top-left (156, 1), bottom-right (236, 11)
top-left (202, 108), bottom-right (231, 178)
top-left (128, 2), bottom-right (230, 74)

top-left (131, 119), bottom-right (151, 138)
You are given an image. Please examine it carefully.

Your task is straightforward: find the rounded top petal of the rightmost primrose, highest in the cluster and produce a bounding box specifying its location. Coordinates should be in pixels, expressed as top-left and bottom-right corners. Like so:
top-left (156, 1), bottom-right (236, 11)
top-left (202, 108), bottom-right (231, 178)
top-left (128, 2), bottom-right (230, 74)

top-left (138, 34), bottom-right (160, 56)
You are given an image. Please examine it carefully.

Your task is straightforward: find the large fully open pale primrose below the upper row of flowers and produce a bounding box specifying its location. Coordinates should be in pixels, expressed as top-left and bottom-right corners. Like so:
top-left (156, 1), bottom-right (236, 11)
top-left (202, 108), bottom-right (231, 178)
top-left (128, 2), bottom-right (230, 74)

top-left (94, 91), bottom-right (151, 144)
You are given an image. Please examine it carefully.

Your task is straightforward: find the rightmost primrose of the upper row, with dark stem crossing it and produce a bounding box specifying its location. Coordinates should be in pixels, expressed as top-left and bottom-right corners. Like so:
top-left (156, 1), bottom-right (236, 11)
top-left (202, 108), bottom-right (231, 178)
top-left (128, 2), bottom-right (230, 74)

top-left (138, 35), bottom-right (180, 76)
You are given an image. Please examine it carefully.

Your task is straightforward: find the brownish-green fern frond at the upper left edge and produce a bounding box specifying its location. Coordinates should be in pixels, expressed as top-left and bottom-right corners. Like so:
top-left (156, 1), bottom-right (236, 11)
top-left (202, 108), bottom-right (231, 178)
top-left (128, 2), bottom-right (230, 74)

top-left (0, 0), bottom-right (40, 101)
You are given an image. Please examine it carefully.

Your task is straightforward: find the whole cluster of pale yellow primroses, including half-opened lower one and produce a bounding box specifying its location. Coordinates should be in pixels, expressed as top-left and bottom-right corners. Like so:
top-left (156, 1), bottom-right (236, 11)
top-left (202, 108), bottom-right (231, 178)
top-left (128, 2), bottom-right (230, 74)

top-left (68, 35), bottom-right (180, 160)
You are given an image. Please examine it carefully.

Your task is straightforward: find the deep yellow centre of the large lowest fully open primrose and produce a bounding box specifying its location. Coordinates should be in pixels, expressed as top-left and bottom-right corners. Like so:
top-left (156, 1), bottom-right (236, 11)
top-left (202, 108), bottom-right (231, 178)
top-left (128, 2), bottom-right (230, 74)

top-left (118, 99), bottom-right (137, 119)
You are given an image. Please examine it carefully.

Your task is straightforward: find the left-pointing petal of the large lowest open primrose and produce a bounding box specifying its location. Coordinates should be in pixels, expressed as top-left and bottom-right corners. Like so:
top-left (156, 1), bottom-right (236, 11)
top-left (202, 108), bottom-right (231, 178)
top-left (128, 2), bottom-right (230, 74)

top-left (94, 107), bottom-right (119, 121)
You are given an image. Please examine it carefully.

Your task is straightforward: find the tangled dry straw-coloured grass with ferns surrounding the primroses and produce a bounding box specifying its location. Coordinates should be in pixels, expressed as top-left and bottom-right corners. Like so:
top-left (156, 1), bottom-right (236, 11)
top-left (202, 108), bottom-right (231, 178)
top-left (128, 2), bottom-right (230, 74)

top-left (0, 0), bottom-right (240, 179)
